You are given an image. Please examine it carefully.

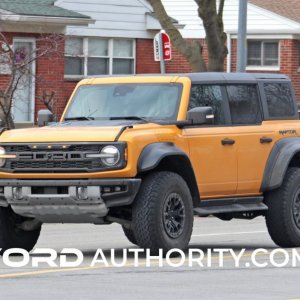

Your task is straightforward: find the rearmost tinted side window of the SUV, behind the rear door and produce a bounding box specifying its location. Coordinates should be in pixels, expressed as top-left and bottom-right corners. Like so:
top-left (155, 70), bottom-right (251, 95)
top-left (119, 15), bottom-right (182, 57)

top-left (264, 83), bottom-right (295, 117)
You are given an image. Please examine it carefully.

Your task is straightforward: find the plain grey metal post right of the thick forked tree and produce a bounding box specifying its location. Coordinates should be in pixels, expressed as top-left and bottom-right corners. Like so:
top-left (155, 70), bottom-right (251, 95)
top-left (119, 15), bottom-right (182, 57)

top-left (237, 0), bottom-right (248, 72)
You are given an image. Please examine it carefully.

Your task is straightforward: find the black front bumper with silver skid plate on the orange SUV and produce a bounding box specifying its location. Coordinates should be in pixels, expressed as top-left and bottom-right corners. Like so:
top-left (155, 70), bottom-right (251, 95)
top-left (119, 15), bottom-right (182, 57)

top-left (0, 178), bottom-right (141, 224)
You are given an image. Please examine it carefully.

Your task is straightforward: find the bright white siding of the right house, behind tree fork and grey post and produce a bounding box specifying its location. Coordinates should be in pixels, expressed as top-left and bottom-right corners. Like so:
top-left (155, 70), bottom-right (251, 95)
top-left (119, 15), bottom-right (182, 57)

top-left (162, 0), bottom-right (300, 38)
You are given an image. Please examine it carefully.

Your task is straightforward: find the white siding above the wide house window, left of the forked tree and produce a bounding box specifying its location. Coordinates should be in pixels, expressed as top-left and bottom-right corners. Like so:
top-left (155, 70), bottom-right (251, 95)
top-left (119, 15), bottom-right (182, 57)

top-left (56, 0), bottom-right (154, 38)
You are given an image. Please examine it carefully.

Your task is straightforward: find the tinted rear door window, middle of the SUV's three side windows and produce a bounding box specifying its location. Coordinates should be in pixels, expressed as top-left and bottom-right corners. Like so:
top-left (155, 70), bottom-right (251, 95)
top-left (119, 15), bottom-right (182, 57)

top-left (227, 84), bottom-right (262, 125)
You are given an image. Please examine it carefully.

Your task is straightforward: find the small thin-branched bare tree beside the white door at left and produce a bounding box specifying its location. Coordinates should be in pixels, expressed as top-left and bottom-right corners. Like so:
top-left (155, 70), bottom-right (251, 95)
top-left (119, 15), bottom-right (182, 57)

top-left (0, 32), bottom-right (64, 128)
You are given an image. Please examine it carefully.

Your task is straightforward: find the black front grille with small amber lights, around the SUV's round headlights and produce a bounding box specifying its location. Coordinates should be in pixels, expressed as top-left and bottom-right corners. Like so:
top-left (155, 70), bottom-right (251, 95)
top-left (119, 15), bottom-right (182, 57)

top-left (1, 142), bottom-right (126, 173)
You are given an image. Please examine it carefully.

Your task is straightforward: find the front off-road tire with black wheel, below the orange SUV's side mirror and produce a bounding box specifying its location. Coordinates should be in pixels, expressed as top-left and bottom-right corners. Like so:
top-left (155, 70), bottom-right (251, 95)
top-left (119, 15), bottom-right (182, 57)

top-left (132, 172), bottom-right (193, 253)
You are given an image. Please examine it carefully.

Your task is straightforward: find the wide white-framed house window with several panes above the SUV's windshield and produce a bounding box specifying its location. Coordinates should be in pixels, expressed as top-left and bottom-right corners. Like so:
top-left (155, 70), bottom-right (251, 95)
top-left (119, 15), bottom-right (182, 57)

top-left (65, 37), bottom-right (135, 78)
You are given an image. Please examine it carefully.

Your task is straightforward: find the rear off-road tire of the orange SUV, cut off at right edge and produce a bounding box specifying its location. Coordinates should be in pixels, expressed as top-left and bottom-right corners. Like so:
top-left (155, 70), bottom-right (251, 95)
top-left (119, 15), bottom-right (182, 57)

top-left (265, 168), bottom-right (300, 247)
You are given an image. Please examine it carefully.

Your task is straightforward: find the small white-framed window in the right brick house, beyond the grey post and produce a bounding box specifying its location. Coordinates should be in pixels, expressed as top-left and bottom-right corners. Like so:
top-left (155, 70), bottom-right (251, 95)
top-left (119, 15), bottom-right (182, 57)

top-left (247, 41), bottom-right (279, 67)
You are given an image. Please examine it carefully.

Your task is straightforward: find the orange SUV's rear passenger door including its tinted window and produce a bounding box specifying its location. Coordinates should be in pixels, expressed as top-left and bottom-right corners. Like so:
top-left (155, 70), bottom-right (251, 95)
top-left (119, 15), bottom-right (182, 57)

top-left (226, 83), bottom-right (275, 196)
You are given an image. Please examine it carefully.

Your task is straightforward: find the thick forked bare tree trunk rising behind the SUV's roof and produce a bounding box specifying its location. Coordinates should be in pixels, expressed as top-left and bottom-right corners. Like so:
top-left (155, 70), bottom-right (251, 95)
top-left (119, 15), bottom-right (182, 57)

top-left (148, 0), bottom-right (228, 72)
